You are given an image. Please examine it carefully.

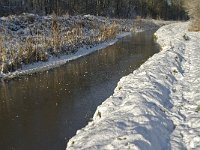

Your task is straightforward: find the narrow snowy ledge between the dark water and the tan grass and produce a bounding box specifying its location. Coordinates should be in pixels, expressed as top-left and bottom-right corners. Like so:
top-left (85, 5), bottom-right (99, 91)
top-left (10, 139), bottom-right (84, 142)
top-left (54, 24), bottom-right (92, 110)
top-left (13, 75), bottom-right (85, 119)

top-left (0, 32), bottom-right (131, 79)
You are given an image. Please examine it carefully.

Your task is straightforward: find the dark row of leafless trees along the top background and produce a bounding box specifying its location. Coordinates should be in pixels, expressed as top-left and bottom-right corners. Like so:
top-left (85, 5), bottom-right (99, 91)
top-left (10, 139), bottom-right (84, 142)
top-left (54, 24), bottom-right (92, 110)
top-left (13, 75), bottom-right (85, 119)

top-left (0, 0), bottom-right (187, 19)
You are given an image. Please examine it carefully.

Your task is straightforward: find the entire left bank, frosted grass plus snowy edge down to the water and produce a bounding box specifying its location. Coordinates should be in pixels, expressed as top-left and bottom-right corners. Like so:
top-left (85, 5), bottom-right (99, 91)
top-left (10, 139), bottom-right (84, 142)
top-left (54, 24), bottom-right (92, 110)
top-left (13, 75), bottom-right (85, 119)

top-left (0, 14), bottom-right (170, 79)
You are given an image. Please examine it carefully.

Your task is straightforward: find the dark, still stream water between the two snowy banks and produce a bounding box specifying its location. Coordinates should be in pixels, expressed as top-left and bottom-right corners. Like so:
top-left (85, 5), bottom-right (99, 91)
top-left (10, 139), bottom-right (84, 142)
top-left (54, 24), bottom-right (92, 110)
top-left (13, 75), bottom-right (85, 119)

top-left (0, 31), bottom-right (158, 150)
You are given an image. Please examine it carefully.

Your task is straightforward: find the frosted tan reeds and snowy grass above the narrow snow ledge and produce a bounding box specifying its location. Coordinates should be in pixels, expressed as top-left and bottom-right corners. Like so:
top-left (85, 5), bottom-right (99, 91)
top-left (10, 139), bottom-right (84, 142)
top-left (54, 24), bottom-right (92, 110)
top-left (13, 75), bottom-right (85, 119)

top-left (0, 14), bottom-right (120, 73)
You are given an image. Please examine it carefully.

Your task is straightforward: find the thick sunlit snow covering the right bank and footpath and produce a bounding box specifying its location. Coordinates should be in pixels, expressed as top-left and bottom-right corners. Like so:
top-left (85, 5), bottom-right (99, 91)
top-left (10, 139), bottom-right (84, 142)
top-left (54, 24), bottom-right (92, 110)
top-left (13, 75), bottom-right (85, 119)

top-left (67, 23), bottom-right (200, 150)
